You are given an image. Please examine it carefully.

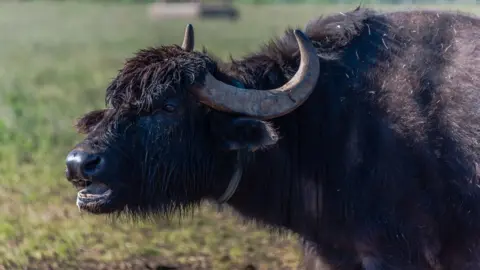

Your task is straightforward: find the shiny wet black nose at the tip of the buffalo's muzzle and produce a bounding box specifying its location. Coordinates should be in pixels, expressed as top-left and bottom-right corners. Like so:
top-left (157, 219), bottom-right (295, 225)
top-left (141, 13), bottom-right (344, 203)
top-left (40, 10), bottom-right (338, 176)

top-left (66, 150), bottom-right (104, 180)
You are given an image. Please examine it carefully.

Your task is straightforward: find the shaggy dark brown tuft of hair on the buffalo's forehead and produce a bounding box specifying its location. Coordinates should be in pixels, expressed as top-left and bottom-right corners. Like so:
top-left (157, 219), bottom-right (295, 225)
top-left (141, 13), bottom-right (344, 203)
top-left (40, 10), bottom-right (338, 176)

top-left (106, 45), bottom-right (215, 109)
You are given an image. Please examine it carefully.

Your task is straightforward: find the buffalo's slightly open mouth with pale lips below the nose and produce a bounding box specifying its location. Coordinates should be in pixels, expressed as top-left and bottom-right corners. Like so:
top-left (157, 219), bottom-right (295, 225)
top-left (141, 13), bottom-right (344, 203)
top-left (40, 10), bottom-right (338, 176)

top-left (77, 182), bottom-right (113, 213)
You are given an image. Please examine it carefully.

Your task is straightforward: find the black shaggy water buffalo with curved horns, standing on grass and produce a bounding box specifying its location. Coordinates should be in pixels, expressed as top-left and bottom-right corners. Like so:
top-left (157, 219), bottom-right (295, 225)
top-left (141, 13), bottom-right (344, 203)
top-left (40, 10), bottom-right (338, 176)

top-left (66, 8), bottom-right (480, 270)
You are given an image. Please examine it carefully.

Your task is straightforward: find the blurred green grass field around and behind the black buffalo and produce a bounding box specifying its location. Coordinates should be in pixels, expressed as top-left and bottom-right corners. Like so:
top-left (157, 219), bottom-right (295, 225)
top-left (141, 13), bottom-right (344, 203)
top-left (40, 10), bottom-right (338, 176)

top-left (0, 2), bottom-right (478, 269)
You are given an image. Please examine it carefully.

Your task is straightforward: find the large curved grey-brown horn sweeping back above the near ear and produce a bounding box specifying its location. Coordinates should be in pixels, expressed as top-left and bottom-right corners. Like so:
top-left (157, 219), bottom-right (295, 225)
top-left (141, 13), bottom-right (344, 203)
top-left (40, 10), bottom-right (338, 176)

top-left (194, 30), bottom-right (320, 119)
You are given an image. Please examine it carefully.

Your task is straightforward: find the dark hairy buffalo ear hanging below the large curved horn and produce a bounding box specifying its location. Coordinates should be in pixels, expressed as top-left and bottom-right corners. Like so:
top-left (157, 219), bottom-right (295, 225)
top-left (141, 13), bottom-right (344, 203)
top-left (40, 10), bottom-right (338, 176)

top-left (219, 117), bottom-right (279, 151)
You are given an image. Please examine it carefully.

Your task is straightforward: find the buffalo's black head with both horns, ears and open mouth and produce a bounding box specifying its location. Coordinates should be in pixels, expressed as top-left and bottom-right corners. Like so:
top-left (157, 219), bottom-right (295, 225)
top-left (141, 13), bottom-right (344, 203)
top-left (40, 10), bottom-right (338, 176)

top-left (66, 25), bottom-right (319, 213)
